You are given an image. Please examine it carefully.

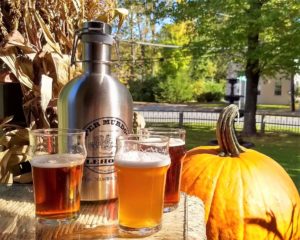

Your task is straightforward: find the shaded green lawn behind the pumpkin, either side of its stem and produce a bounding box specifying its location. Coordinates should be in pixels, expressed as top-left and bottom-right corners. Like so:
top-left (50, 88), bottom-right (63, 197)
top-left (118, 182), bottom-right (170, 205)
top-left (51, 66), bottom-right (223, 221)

top-left (186, 126), bottom-right (300, 191)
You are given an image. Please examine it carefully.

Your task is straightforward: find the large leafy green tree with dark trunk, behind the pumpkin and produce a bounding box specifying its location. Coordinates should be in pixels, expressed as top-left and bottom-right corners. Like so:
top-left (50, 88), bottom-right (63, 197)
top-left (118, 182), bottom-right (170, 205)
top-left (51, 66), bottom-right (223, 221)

top-left (172, 0), bottom-right (300, 135)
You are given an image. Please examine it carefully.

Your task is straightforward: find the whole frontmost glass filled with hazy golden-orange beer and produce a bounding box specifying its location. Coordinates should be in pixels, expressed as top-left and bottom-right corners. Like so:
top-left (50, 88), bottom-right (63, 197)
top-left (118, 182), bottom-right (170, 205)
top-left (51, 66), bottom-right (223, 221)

top-left (114, 134), bottom-right (170, 236)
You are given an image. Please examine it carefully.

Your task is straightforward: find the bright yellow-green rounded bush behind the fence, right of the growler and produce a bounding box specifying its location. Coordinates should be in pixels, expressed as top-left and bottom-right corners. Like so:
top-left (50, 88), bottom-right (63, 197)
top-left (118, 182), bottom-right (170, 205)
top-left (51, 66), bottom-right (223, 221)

top-left (155, 70), bottom-right (193, 103)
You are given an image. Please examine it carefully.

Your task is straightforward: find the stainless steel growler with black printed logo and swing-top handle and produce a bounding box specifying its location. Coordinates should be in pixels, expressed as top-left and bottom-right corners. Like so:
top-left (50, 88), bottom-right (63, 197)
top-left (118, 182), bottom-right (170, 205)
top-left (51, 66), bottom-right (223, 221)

top-left (58, 21), bottom-right (133, 201)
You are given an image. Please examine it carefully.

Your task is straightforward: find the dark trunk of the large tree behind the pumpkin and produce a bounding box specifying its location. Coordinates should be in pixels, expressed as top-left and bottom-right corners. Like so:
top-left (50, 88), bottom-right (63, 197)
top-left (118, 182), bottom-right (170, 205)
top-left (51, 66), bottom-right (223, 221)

top-left (242, 1), bottom-right (262, 136)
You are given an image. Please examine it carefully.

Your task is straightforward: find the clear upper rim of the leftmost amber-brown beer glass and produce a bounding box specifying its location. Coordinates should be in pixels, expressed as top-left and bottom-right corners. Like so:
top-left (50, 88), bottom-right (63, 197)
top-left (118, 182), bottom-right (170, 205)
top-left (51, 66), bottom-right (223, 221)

top-left (29, 128), bottom-right (85, 136)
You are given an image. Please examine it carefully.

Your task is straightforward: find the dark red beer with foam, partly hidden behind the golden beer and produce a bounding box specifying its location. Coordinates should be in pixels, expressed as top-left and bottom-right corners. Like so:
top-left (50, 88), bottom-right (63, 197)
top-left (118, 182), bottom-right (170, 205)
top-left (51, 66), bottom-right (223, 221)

top-left (165, 138), bottom-right (186, 209)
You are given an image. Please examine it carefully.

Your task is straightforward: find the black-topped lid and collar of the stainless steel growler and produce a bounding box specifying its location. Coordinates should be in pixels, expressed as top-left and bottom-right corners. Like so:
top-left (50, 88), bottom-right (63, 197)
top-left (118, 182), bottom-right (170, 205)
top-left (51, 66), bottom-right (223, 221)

top-left (80, 21), bottom-right (114, 45)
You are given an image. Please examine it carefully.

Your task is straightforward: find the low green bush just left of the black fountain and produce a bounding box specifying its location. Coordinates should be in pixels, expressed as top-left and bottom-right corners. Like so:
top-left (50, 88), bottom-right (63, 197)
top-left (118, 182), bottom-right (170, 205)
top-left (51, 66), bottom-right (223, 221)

top-left (194, 81), bottom-right (225, 102)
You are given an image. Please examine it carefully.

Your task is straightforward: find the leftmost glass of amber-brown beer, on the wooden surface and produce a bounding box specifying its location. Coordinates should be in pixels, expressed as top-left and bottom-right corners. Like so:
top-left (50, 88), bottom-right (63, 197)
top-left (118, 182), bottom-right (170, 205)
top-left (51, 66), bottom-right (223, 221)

top-left (29, 129), bottom-right (86, 225)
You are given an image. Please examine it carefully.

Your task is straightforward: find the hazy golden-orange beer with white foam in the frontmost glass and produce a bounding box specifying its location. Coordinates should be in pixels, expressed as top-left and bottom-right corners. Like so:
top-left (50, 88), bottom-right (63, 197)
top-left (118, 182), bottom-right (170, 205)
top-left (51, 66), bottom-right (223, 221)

top-left (115, 151), bottom-right (170, 230)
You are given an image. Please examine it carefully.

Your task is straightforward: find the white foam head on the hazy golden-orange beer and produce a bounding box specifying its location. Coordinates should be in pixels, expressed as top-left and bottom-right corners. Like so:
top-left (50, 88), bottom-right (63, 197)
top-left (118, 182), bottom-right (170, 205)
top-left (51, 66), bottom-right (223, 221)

top-left (115, 150), bottom-right (170, 168)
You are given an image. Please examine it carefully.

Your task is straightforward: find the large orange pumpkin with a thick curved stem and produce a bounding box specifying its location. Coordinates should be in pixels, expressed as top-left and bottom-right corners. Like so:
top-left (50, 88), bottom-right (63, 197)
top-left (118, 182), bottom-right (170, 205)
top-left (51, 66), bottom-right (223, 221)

top-left (181, 105), bottom-right (300, 240)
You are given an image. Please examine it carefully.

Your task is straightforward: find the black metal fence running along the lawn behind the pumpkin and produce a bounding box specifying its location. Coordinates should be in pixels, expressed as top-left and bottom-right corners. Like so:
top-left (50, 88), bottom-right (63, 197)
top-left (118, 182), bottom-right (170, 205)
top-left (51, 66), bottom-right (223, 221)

top-left (137, 110), bottom-right (300, 134)
